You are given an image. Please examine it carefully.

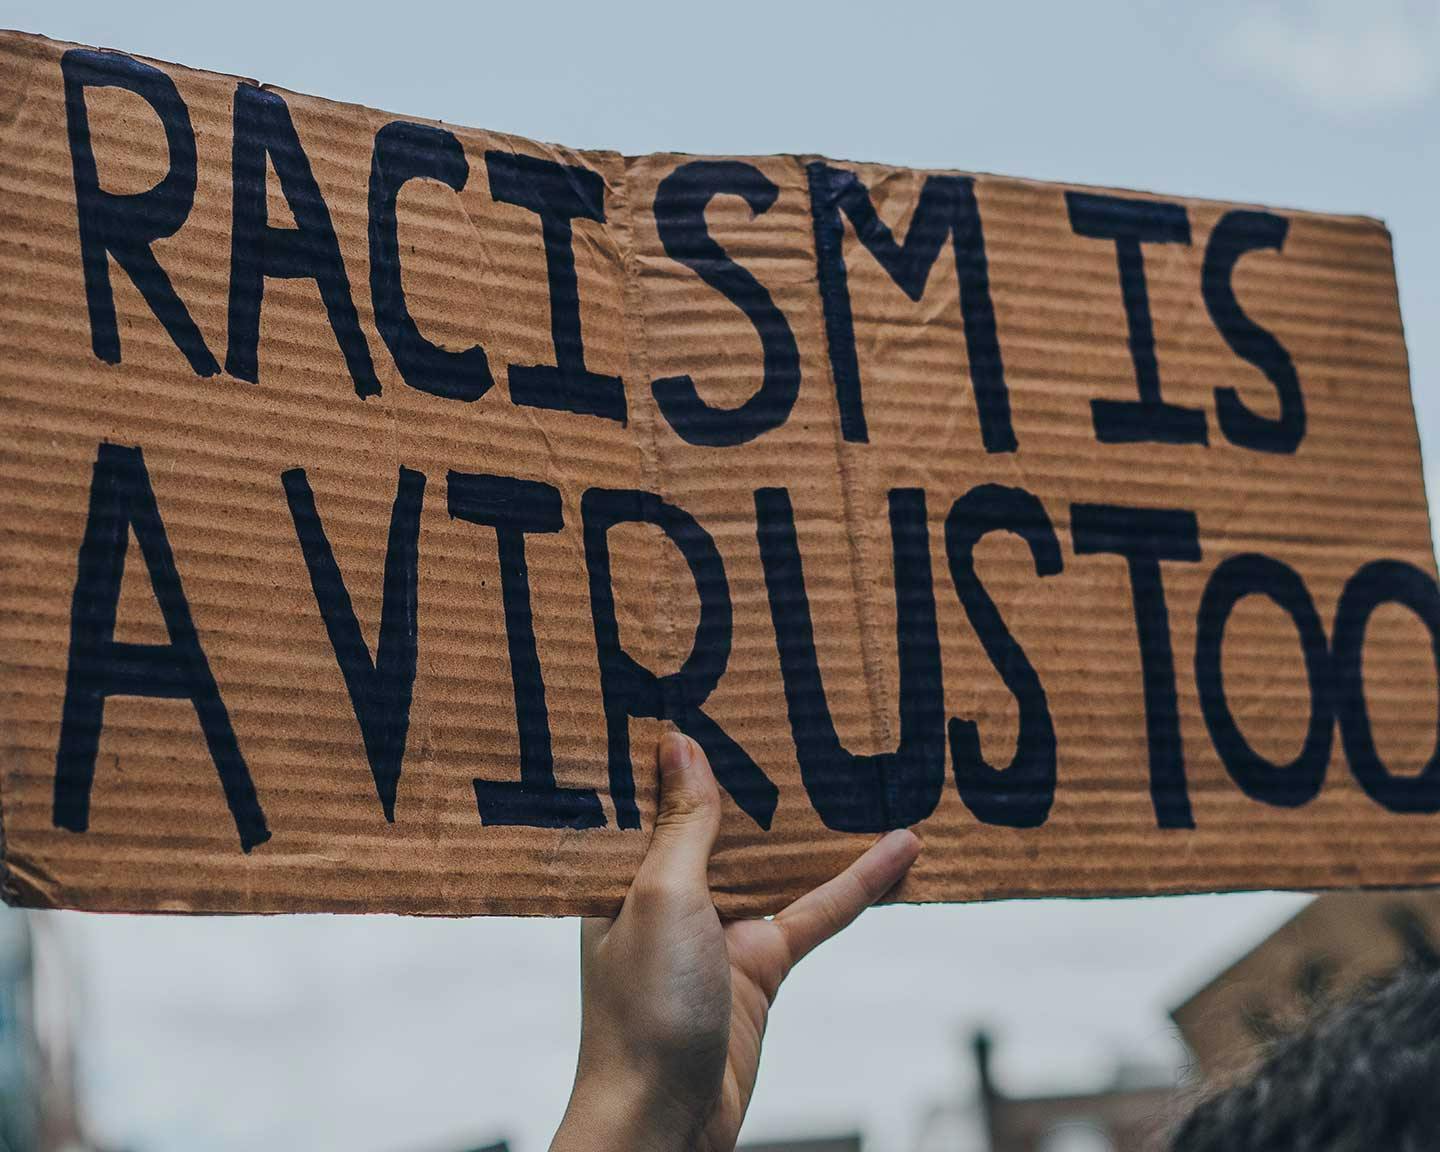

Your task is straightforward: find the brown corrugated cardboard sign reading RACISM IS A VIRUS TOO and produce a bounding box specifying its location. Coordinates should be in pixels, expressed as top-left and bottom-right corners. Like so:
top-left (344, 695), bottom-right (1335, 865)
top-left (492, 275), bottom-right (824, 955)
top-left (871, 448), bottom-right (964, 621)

top-left (0, 27), bottom-right (1440, 914)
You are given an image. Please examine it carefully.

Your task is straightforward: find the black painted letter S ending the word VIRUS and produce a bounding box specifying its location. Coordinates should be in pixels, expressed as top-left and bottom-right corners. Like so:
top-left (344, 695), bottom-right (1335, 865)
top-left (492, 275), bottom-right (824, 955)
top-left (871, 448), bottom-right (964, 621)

top-left (945, 484), bottom-right (1064, 828)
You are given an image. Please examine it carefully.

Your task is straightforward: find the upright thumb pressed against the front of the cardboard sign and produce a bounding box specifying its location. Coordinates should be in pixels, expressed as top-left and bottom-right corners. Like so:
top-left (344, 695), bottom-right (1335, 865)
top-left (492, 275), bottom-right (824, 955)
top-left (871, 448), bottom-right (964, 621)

top-left (636, 732), bottom-right (720, 887)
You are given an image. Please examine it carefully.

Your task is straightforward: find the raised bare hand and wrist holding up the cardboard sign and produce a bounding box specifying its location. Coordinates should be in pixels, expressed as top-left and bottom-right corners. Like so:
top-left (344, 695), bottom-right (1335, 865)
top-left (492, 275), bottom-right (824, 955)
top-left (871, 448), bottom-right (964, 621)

top-left (550, 734), bottom-right (920, 1152)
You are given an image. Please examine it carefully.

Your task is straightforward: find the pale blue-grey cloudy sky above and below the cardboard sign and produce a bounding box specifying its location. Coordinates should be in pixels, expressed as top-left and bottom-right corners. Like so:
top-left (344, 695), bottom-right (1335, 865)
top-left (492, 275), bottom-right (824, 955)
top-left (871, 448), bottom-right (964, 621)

top-left (11, 0), bottom-right (1440, 1152)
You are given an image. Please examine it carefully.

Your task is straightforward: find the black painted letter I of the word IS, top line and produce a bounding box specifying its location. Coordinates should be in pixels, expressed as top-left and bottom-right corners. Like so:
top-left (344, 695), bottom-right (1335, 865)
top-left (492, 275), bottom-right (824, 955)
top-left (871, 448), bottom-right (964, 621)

top-left (1066, 192), bottom-right (1210, 444)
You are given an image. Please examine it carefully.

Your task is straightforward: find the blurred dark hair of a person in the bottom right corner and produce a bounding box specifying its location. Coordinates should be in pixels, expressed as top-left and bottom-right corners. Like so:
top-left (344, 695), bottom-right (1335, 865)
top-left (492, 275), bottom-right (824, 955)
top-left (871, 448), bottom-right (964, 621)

top-left (1169, 968), bottom-right (1440, 1152)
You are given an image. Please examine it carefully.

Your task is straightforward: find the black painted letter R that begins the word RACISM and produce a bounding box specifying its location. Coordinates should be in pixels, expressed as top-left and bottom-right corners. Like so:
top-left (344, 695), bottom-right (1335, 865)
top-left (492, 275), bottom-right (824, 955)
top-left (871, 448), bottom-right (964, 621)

top-left (60, 48), bottom-right (220, 376)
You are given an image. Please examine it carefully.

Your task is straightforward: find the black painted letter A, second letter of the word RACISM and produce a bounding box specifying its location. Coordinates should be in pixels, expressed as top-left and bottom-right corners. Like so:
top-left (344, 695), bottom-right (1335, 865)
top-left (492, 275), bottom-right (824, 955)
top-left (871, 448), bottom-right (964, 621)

top-left (225, 84), bottom-right (380, 397)
